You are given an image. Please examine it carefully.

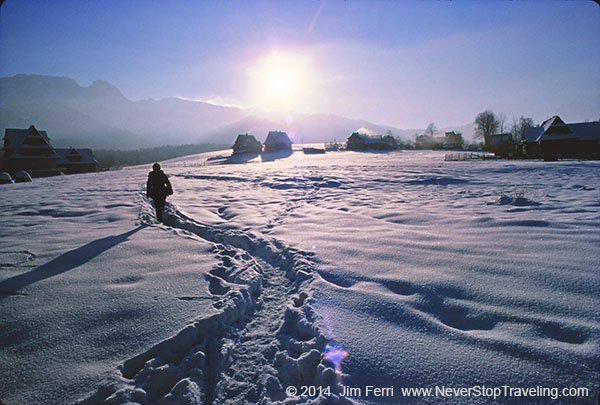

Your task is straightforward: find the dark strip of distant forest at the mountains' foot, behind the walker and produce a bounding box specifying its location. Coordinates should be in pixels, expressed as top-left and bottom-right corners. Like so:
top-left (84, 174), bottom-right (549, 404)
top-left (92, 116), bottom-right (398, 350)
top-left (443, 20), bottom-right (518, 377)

top-left (94, 143), bottom-right (230, 170)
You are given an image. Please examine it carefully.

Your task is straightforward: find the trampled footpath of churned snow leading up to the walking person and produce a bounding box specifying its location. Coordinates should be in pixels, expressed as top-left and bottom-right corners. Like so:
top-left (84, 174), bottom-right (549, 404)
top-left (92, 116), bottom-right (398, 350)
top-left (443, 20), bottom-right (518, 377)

top-left (81, 198), bottom-right (349, 404)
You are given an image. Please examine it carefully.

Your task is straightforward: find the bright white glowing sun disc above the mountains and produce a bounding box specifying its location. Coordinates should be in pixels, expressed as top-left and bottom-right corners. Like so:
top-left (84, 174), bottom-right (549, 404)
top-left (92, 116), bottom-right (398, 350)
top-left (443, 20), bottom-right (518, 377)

top-left (248, 50), bottom-right (316, 112)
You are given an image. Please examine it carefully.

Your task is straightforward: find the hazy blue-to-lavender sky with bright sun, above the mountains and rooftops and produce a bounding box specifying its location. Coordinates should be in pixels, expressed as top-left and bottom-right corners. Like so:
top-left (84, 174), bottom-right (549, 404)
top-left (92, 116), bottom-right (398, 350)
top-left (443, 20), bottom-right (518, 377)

top-left (0, 0), bottom-right (600, 128)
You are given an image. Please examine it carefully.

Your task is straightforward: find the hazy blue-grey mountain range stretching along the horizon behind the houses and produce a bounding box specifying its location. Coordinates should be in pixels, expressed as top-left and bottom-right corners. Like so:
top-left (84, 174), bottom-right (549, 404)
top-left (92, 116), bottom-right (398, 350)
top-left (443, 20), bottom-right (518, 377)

top-left (0, 74), bottom-right (473, 150)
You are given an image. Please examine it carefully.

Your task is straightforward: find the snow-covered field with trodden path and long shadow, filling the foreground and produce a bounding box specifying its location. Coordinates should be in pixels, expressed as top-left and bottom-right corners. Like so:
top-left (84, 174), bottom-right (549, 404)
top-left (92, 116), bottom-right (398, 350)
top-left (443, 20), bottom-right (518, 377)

top-left (0, 152), bottom-right (600, 404)
